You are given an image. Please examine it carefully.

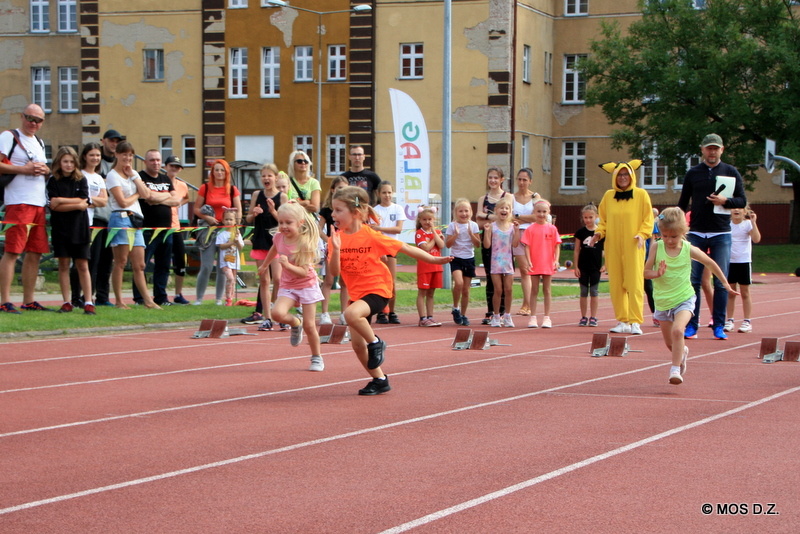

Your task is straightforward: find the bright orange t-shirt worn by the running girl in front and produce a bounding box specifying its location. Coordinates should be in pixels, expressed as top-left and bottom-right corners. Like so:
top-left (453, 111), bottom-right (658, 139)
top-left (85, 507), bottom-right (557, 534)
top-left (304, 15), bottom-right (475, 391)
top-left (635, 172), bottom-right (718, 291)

top-left (328, 224), bottom-right (405, 301)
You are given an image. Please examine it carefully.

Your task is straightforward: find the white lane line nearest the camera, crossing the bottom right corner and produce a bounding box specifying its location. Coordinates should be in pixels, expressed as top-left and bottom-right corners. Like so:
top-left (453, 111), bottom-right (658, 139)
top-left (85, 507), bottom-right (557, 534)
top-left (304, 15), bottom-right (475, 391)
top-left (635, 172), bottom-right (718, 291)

top-left (381, 386), bottom-right (800, 534)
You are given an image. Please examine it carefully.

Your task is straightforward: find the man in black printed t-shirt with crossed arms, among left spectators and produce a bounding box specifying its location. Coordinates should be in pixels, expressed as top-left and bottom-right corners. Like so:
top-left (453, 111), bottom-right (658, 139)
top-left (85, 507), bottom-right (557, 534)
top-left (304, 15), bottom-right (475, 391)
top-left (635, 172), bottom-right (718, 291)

top-left (133, 150), bottom-right (180, 306)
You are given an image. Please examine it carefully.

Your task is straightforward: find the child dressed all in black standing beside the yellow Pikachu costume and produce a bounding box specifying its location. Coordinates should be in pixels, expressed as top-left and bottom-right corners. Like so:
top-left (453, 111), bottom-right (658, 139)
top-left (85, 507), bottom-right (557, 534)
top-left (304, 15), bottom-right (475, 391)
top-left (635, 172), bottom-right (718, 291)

top-left (572, 204), bottom-right (605, 326)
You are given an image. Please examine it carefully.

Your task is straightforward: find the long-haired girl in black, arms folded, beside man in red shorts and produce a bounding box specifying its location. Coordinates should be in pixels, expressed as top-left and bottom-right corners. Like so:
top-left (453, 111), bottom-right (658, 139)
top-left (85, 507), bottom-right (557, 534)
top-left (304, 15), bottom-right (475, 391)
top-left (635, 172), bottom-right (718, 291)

top-left (47, 146), bottom-right (95, 315)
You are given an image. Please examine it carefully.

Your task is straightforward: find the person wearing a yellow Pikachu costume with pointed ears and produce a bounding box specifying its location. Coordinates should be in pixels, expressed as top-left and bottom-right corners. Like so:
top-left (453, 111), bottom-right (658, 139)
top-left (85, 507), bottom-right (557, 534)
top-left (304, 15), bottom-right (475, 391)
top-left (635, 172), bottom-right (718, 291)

top-left (592, 159), bottom-right (653, 334)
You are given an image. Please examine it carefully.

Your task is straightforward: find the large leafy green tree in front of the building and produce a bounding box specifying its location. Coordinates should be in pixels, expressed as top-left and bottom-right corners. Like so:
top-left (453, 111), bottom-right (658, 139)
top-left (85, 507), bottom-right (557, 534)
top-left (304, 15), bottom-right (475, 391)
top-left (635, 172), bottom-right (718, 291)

top-left (579, 0), bottom-right (800, 243)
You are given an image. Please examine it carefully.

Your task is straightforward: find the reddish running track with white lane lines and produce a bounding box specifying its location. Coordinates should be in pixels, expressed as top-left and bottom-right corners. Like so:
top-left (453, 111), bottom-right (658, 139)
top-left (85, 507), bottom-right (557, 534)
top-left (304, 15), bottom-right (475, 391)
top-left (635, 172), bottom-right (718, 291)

top-left (0, 275), bottom-right (800, 534)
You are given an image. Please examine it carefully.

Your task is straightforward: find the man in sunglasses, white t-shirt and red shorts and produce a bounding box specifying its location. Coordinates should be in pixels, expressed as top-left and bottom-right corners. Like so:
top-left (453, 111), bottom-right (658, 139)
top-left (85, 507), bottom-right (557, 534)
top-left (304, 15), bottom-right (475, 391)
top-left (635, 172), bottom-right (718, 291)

top-left (0, 104), bottom-right (50, 313)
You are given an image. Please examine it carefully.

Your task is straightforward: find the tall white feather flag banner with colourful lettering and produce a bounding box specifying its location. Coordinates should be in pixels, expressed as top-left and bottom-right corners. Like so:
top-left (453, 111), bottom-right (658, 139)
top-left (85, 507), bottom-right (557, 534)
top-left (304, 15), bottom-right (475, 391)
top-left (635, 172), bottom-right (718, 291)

top-left (389, 89), bottom-right (431, 243)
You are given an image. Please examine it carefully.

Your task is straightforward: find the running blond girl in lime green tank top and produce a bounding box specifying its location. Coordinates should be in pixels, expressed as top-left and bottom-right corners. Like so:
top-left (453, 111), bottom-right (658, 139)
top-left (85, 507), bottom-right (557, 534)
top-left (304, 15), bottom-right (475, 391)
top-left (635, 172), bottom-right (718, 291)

top-left (644, 208), bottom-right (738, 385)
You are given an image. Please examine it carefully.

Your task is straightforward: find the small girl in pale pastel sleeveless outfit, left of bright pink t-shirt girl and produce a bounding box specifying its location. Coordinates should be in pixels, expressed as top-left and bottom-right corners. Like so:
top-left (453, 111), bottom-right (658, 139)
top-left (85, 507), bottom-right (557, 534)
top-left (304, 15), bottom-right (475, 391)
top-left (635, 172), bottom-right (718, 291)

top-left (483, 195), bottom-right (519, 328)
